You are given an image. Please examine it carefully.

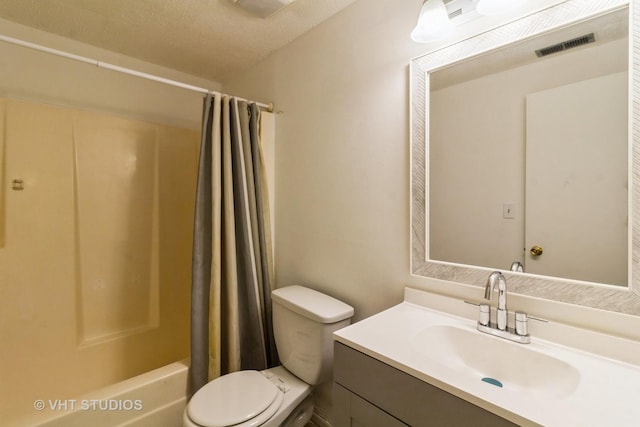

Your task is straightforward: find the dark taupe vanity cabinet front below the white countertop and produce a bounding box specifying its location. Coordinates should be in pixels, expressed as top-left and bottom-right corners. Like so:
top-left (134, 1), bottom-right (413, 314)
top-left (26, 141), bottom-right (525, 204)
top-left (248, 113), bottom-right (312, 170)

top-left (333, 342), bottom-right (516, 427)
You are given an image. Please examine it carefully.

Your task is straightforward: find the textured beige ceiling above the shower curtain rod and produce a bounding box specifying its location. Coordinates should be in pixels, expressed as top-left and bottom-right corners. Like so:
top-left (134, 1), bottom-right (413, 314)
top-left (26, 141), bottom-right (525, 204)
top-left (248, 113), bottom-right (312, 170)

top-left (0, 0), bottom-right (355, 81)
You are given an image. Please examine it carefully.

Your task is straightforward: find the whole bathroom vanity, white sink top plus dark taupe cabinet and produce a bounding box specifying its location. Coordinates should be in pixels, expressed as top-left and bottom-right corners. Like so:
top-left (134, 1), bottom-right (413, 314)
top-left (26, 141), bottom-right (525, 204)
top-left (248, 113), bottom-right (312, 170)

top-left (333, 288), bottom-right (640, 427)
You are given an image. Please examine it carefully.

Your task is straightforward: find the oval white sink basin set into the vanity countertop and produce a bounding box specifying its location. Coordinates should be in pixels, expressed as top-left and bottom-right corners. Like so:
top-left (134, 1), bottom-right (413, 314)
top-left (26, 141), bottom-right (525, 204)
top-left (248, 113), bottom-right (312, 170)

top-left (411, 325), bottom-right (580, 399)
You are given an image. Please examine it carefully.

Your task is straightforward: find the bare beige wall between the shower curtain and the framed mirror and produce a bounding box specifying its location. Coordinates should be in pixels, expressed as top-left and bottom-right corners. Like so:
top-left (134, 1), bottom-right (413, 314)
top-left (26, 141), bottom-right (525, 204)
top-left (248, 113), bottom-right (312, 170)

top-left (223, 0), bottom-right (424, 319)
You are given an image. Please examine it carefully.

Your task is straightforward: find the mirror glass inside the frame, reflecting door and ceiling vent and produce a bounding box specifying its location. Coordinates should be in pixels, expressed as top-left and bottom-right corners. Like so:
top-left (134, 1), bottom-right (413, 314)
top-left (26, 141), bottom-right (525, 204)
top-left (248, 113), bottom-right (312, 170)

top-left (427, 8), bottom-right (629, 286)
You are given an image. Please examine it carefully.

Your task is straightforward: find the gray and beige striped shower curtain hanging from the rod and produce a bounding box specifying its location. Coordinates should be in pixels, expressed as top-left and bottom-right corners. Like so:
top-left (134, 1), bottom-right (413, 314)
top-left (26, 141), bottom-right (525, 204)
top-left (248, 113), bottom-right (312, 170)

top-left (190, 95), bottom-right (278, 393)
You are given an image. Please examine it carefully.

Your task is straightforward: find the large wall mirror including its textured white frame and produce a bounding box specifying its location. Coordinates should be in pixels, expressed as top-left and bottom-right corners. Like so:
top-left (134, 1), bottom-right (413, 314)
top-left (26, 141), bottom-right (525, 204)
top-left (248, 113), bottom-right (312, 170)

top-left (411, 0), bottom-right (640, 314)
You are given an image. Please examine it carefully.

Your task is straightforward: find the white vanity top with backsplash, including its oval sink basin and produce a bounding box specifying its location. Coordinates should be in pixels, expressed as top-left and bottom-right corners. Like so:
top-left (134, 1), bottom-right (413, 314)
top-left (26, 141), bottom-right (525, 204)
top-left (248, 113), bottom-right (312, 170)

top-left (334, 288), bottom-right (640, 427)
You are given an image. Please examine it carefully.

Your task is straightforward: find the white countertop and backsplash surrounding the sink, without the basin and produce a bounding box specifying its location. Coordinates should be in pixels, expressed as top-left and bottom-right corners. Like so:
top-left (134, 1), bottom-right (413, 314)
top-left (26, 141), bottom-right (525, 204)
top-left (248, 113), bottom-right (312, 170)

top-left (334, 289), bottom-right (640, 427)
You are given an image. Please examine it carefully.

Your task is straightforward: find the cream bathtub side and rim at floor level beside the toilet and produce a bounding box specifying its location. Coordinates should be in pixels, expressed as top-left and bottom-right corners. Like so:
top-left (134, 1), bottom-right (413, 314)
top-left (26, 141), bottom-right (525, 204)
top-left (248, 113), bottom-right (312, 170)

top-left (11, 360), bottom-right (189, 427)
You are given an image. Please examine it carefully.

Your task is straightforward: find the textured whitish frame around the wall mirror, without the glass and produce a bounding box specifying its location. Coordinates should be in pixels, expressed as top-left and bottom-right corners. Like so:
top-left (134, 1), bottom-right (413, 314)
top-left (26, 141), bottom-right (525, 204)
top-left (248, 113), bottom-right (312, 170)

top-left (410, 0), bottom-right (640, 315)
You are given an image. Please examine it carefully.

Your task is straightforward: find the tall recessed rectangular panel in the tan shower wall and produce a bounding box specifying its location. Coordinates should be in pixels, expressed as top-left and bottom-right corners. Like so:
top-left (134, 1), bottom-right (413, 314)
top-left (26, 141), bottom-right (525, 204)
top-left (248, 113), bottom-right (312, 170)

top-left (73, 114), bottom-right (159, 344)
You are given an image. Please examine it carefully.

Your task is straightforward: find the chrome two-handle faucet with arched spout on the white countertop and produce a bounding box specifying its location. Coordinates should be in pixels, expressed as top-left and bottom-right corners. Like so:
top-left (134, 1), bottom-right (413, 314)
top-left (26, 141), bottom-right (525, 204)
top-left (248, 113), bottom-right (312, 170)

top-left (478, 271), bottom-right (531, 344)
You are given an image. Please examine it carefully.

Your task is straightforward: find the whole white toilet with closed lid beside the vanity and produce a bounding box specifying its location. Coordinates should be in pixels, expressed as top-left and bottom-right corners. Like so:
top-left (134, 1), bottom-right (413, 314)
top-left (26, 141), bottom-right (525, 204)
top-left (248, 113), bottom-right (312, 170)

top-left (183, 286), bottom-right (353, 427)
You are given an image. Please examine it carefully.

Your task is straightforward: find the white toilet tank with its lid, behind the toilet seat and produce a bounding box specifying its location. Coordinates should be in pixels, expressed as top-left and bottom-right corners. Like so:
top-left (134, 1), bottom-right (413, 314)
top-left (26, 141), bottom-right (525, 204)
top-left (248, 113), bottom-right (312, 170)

top-left (271, 286), bottom-right (353, 385)
